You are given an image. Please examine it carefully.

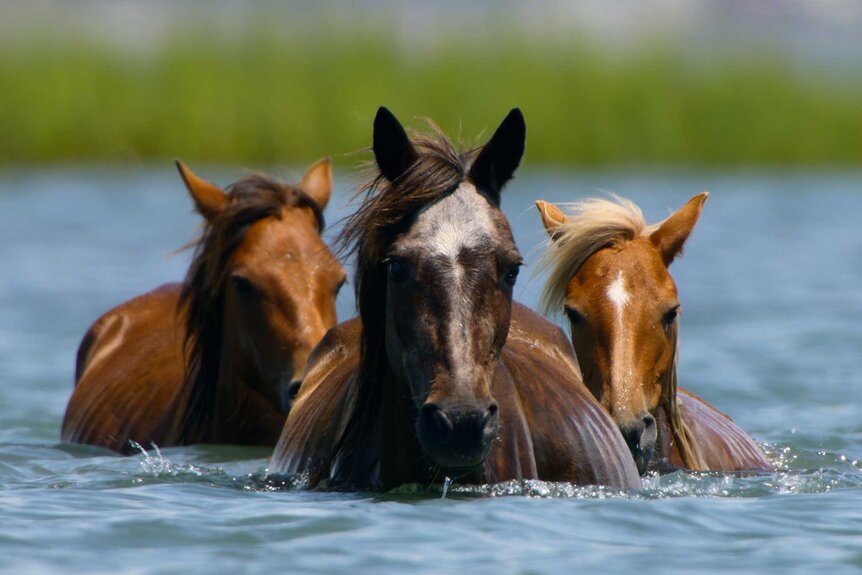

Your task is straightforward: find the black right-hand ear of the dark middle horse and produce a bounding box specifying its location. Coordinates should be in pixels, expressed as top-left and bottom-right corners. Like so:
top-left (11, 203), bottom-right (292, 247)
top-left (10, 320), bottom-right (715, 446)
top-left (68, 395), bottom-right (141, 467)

top-left (470, 108), bottom-right (527, 205)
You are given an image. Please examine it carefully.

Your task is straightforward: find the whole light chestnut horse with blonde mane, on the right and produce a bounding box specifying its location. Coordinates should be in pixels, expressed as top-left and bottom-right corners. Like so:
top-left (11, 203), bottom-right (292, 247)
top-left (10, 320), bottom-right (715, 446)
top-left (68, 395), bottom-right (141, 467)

top-left (536, 192), bottom-right (771, 474)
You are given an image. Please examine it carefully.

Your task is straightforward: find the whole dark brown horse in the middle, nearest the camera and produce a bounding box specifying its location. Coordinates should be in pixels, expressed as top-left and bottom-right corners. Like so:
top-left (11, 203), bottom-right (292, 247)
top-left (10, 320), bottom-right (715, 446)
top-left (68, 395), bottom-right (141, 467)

top-left (272, 108), bottom-right (640, 489)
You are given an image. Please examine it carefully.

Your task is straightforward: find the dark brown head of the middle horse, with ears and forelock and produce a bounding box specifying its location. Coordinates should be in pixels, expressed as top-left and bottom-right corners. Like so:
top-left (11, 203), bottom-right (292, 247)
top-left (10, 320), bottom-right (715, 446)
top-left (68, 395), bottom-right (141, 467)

top-left (344, 108), bottom-right (526, 469)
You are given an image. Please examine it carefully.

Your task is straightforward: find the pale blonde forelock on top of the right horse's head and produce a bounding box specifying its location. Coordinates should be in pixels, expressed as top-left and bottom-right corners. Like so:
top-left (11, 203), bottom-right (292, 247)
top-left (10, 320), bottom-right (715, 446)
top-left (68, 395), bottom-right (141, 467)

top-left (538, 194), bottom-right (661, 316)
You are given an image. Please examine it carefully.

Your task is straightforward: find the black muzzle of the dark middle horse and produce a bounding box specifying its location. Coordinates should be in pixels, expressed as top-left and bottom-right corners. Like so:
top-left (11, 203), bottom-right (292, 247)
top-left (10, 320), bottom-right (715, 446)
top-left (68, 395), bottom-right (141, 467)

top-left (416, 402), bottom-right (500, 469)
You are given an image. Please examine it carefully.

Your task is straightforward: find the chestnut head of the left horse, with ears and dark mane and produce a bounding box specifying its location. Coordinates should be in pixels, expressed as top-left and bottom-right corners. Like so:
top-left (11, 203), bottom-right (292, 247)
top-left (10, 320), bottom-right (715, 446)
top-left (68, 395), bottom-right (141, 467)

top-left (177, 159), bottom-right (345, 440)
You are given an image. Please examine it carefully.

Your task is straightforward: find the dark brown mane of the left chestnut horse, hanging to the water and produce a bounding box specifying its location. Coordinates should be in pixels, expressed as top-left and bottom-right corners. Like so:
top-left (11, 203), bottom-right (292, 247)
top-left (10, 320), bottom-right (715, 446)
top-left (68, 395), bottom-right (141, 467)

top-left (177, 174), bottom-right (324, 444)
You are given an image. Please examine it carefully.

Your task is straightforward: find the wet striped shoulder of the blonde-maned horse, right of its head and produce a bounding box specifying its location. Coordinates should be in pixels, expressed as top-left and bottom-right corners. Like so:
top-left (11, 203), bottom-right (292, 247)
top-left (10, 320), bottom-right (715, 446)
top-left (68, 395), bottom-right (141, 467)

top-left (677, 388), bottom-right (772, 471)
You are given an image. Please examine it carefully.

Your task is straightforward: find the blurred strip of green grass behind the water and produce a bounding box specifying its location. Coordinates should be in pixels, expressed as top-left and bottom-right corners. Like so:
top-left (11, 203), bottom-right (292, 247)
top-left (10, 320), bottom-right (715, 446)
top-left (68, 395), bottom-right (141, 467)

top-left (0, 31), bottom-right (862, 166)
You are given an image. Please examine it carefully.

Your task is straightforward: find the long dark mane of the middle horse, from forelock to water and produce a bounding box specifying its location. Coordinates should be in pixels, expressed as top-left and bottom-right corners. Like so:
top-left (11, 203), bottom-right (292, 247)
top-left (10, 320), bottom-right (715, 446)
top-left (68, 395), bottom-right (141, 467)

top-left (320, 125), bottom-right (474, 485)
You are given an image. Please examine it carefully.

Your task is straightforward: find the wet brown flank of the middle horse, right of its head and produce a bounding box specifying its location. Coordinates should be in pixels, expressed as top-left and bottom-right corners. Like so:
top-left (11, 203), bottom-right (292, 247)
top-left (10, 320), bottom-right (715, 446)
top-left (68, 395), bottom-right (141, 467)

top-left (501, 303), bottom-right (640, 488)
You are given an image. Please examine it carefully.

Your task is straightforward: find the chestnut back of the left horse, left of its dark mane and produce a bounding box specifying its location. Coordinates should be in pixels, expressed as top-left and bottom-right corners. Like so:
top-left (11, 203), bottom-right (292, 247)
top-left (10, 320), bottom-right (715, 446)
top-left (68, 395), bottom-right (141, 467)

top-left (61, 284), bottom-right (185, 451)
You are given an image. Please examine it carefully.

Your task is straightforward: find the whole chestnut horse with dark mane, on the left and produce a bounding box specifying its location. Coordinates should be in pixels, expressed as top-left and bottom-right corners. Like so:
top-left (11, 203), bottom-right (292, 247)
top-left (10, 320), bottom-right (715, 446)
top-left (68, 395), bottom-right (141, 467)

top-left (62, 159), bottom-right (345, 453)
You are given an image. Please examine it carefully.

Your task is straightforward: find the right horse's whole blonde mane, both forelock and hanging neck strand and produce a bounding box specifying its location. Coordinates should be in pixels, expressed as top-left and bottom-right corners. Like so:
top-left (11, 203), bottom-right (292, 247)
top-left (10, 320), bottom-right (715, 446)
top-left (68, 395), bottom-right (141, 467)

top-left (537, 194), bottom-right (707, 470)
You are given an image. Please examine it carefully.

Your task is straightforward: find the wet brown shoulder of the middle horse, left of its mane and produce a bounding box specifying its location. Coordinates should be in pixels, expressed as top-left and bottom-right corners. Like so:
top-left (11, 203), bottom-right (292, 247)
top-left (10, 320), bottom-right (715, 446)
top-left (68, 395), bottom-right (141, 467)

top-left (271, 318), bottom-right (362, 480)
